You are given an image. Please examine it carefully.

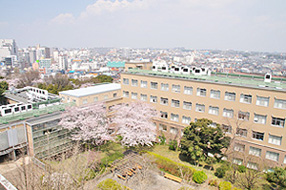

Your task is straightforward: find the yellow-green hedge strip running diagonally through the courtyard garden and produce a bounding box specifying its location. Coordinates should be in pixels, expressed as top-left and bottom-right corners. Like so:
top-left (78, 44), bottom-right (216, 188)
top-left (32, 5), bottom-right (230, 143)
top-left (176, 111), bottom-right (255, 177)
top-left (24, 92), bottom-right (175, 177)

top-left (147, 152), bottom-right (196, 181)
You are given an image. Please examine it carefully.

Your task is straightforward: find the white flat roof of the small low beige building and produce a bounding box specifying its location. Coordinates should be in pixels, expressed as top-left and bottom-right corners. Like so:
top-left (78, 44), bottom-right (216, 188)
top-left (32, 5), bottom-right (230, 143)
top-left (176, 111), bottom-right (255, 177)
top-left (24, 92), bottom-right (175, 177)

top-left (59, 83), bottom-right (121, 97)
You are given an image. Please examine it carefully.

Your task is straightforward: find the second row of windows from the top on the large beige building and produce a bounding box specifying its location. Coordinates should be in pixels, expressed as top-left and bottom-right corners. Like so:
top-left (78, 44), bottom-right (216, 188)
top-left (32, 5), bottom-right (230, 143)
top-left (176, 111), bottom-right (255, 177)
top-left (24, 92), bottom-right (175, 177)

top-left (123, 91), bottom-right (285, 127)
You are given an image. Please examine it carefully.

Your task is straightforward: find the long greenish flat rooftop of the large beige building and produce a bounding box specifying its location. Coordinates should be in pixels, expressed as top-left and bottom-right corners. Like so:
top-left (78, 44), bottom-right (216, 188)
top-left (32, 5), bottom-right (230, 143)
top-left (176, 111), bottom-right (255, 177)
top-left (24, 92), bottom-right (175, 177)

top-left (125, 69), bottom-right (286, 92)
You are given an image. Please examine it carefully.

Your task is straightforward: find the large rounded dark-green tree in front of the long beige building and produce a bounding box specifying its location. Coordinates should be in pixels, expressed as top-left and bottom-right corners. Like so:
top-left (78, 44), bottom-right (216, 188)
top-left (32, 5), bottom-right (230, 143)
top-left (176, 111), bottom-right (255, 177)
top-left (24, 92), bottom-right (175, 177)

top-left (181, 119), bottom-right (230, 163)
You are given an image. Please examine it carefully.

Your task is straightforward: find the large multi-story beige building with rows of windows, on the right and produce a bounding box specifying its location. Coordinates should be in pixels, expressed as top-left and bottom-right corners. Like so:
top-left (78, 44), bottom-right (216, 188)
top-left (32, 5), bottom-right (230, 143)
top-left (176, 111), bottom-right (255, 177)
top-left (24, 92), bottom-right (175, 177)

top-left (121, 69), bottom-right (286, 169)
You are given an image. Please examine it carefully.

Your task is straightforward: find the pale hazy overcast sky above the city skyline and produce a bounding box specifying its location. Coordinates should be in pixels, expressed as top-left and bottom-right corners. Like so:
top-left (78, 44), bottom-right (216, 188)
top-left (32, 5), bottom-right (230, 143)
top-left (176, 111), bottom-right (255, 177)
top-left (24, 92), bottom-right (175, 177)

top-left (0, 0), bottom-right (286, 52)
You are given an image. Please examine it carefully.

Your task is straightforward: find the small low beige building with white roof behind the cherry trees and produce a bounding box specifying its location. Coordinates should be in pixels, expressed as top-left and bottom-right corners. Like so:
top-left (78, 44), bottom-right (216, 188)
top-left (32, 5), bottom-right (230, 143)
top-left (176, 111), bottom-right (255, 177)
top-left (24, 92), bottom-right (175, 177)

top-left (59, 83), bottom-right (121, 106)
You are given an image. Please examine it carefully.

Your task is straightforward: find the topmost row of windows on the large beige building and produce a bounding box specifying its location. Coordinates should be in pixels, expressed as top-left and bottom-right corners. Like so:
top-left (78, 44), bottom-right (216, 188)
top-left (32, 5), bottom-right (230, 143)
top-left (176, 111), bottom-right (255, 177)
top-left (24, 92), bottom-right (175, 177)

top-left (123, 78), bottom-right (286, 109)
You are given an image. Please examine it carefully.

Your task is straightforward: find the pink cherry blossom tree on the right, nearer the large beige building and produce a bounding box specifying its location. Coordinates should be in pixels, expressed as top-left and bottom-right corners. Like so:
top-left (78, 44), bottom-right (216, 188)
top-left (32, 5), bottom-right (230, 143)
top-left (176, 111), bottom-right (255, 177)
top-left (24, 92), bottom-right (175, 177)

top-left (112, 102), bottom-right (158, 147)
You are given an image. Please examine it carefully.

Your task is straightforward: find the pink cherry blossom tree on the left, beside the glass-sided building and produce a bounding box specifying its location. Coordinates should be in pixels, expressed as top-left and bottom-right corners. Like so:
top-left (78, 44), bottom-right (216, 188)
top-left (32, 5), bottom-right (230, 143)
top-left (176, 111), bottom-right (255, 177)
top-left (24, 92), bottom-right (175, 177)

top-left (59, 102), bottom-right (113, 145)
